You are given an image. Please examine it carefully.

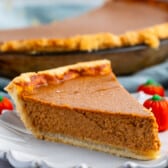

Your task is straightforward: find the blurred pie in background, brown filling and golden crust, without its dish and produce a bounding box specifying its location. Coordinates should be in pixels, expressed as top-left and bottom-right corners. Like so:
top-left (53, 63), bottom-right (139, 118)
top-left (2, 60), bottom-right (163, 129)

top-left (0, 0), bottom-right (168, 52)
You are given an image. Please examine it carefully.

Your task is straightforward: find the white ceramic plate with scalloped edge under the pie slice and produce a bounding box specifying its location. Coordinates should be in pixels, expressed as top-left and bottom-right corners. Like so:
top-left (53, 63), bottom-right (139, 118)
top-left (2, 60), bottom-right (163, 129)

top-left (0, 93), bottom-right (168, 168)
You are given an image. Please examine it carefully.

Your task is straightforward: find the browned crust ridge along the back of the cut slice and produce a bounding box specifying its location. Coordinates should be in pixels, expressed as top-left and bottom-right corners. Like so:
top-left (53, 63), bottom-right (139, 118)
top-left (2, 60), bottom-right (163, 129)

top-left (5, 59), bottom-right (111, 91)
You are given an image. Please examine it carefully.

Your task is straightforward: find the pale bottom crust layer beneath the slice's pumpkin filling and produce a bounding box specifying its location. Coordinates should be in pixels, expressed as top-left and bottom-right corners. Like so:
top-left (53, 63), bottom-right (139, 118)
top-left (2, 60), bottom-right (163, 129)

top-left (34, 131), bottom-right (159, 160)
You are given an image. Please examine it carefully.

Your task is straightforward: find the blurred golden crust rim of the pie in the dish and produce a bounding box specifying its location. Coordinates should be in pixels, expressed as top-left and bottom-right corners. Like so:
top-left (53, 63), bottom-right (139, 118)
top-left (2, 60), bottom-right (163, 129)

top-left (0, 23), bottom-right (168, 53)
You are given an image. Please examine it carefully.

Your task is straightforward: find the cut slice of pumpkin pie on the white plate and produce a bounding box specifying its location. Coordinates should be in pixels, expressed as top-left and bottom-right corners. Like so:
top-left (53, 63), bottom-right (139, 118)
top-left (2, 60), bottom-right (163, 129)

top-left (5, 60), bottom-right (160, 160)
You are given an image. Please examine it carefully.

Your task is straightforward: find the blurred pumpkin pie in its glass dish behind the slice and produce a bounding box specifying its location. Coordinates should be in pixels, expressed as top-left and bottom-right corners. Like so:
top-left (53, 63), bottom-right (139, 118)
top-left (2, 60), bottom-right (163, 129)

top-left (0, 0), bottom-right (168, 78)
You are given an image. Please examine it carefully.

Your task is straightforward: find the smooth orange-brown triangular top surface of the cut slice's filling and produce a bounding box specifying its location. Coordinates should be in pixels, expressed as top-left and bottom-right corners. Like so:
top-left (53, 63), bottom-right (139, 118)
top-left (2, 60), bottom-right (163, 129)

top-left (23, 75), bottom-right (151, 116)
